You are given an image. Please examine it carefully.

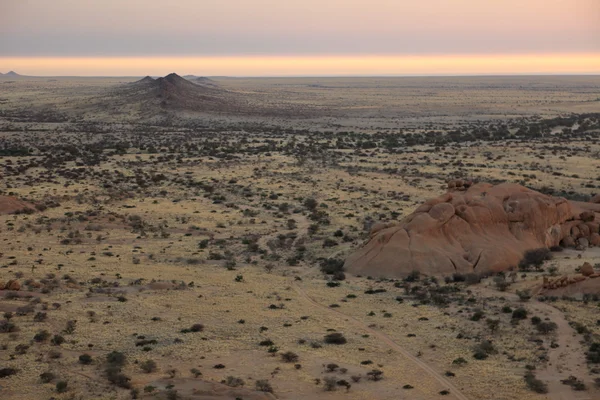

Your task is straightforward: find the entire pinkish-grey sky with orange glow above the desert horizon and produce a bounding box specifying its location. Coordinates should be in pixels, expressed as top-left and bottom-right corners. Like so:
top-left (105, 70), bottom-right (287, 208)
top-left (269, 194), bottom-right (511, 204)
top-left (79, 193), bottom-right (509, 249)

top-left (0, 0), bottom-right (600, 76)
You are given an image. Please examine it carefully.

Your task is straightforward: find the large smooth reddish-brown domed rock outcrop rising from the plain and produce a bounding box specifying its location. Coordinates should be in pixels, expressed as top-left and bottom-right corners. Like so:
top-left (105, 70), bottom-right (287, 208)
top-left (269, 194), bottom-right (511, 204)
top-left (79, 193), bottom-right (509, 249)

top-left (345, 182), bottom-right (600, 277)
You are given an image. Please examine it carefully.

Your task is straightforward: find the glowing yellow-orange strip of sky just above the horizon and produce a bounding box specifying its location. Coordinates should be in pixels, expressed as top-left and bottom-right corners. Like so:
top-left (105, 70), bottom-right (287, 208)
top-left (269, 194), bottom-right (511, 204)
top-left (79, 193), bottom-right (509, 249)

top-left (0, 54), bottom-right (600, 76)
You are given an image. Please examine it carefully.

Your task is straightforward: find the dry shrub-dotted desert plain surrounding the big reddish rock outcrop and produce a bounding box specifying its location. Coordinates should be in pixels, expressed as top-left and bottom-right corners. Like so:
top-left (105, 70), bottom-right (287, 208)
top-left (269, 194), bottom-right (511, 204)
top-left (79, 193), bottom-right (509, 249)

top-left (0, 75), bottom-right (600, 400)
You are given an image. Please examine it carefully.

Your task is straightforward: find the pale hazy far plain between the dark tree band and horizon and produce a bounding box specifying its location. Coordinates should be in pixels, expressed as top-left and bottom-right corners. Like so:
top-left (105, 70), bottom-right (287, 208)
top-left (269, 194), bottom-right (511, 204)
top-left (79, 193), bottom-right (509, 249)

top-left (2, 76), bottom-right (600, 122)
